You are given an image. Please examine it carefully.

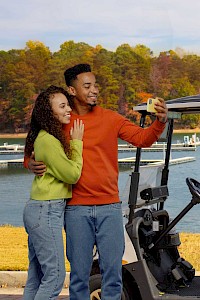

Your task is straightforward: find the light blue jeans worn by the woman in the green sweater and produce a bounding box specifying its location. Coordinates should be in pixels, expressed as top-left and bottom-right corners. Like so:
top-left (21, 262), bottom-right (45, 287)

top-left (23, 199), bottom-right (66, 300)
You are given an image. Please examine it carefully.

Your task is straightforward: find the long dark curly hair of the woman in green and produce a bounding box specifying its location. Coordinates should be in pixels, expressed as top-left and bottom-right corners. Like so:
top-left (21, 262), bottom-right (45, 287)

top-left (24, 85), bottom-right (71, 157)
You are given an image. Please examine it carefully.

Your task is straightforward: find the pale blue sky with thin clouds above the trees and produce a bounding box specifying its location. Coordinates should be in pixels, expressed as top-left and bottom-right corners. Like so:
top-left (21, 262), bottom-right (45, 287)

top-left (0, 0), bottom-right (200, 55)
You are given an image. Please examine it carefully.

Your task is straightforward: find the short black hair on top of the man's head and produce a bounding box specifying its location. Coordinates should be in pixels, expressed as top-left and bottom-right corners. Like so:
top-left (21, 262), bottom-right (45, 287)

top-left (64, 64), bottom-right (91, 86)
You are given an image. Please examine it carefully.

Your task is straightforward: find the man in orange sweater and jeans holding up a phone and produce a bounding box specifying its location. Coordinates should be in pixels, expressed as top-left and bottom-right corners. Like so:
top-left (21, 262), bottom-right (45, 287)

top-left (26, 64), bottom-right (167, 300)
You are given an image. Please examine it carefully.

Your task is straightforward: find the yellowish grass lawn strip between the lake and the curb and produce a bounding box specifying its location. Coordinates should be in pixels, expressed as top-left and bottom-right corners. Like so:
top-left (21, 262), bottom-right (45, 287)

top-left (0, 225), bottom-right (200, 271)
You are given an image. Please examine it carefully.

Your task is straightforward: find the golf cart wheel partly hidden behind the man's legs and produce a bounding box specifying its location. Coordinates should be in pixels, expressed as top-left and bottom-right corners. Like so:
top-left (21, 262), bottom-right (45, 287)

top-left (90, 274), bottom-right (132, 300)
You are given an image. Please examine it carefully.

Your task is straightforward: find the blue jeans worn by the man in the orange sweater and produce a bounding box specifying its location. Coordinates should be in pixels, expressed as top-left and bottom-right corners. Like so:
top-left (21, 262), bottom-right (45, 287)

top-left (65, 203), bottom-right (124, 300)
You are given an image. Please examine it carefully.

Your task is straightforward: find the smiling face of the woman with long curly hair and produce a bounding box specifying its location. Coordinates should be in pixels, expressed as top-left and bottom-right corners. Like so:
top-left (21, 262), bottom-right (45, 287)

top-left (50, 93), bottom-right (72, 124)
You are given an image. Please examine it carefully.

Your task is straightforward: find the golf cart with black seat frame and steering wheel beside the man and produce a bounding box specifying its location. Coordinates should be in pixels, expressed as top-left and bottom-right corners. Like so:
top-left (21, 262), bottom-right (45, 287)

top-left (90, 95), bottom-right (200, 300)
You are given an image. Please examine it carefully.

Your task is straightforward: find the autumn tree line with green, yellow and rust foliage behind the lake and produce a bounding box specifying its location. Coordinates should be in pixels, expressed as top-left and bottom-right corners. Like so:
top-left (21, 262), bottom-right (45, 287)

top-left (0, 40), bottom-right (200, 132)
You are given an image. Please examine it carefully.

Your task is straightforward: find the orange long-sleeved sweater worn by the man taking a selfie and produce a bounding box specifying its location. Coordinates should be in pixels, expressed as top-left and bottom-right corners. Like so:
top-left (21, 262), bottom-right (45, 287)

top-left (25, 106), bottom-right (165, 205)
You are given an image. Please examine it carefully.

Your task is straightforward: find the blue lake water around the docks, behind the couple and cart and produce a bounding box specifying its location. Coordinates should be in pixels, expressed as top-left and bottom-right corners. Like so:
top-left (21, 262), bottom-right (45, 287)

top-left (0, 134), bottom-right (200, 232)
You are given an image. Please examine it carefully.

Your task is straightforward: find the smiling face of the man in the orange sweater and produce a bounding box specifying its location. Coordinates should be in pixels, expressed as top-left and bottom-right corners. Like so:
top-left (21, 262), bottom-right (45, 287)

top-left (70, 72), bottom-right (99, 106)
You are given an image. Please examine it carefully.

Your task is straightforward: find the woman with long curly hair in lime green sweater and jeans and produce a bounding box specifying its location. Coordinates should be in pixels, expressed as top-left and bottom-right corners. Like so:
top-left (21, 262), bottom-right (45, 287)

top-left (23, 86), bottom-right (84, 300)
